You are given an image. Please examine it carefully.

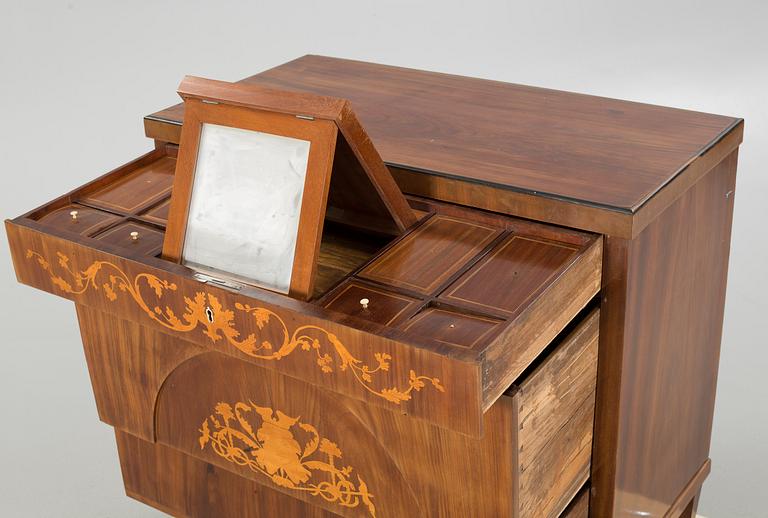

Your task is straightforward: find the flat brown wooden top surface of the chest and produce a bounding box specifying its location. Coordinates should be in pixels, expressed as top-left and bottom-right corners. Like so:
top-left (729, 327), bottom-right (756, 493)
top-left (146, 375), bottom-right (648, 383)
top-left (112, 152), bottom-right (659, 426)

top-left (149, 56), bottom-right (738, 210)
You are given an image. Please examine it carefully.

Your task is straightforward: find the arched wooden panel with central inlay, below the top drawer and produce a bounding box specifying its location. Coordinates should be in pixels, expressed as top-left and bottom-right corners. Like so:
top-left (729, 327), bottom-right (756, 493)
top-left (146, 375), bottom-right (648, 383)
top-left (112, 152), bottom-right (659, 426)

top-left (156, 352), bottom-right (421, 517)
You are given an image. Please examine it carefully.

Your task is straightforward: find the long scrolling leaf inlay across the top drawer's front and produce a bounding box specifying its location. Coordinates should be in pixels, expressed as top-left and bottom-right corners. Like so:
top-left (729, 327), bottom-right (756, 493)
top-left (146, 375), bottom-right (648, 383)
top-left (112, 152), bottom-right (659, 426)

top-left (27, 250), bottom-right (445, 405)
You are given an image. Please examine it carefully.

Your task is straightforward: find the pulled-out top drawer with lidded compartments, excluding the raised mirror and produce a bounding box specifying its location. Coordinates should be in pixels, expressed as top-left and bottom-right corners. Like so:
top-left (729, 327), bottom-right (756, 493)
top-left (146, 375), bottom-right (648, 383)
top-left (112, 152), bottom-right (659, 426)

top-left (6, 146), bottom-right (602, 436)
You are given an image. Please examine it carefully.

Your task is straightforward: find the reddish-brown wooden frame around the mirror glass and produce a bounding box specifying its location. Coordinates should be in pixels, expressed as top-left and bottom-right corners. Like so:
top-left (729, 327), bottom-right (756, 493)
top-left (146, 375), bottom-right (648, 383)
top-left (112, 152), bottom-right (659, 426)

top-left (163, 83), bottom-right (338, 300)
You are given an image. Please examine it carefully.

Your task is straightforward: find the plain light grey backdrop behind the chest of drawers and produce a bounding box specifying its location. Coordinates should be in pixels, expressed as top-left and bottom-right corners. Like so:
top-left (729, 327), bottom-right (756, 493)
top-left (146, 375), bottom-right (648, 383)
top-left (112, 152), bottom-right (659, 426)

top-left (0, 0), bottom-right (768, 518)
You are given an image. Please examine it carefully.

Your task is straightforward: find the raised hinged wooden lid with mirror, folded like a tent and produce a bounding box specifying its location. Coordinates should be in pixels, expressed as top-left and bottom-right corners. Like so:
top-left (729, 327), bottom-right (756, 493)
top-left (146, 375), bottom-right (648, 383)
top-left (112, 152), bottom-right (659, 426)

top-left (163, 77), bottom-right (416, 299)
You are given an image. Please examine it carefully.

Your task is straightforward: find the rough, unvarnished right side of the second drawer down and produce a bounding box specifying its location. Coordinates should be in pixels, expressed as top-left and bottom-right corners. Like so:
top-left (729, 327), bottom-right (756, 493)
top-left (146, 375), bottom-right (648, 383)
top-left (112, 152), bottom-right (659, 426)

top-left (514, 310), bottom-right (599, 517)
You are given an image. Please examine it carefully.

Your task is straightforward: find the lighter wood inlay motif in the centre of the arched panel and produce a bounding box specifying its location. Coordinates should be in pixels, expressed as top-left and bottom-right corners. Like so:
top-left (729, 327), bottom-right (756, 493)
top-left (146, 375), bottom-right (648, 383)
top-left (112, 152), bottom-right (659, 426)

top-left (199, 401), bottom-right (376, 517)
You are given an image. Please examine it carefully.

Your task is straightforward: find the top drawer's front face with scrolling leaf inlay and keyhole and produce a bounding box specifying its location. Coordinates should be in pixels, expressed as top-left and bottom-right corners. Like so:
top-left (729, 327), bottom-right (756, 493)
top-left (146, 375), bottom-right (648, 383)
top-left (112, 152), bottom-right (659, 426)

top-left (6, 221), bottom-right (482, 435)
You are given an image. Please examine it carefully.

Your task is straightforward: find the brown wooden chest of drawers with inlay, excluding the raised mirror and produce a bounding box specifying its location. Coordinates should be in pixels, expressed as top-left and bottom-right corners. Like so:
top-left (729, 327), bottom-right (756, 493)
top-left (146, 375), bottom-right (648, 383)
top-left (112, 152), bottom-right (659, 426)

top-left (6, 56), bottom-right (742, 517)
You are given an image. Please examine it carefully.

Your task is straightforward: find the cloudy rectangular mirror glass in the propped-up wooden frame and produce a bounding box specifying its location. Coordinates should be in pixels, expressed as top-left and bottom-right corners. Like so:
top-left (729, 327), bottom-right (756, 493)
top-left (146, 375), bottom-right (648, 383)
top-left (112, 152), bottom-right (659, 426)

top-left (182, 124), bottom-right (310, 293)
